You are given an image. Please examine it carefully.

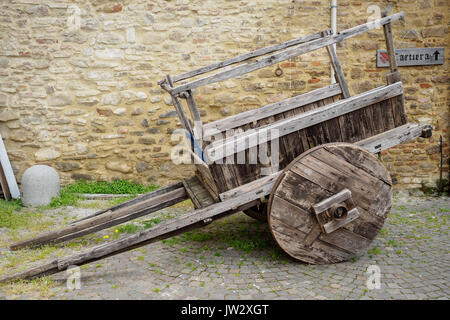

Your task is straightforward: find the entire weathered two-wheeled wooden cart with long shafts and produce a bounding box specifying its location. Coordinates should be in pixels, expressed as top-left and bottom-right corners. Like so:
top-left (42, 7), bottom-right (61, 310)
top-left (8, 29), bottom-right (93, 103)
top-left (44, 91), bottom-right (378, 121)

top-left (3, 13), bottom-right (431, 280)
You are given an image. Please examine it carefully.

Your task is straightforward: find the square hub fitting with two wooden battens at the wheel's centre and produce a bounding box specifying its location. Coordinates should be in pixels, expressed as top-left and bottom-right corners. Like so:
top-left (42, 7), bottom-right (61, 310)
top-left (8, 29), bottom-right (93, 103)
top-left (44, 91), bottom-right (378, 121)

top-left (312, 189), bottom-right (359, 233)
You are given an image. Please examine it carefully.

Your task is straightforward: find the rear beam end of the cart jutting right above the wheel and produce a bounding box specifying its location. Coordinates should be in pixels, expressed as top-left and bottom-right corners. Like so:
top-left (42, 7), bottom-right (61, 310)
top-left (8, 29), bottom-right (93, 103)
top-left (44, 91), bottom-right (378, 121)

top-left (356, 123), bottom-right (432, 153)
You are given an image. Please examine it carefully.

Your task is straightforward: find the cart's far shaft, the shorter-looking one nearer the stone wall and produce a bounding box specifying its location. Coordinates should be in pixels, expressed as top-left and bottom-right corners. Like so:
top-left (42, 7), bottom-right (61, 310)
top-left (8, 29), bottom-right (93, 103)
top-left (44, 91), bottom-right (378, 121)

top-left (10, 187), bottom-right (187, 250)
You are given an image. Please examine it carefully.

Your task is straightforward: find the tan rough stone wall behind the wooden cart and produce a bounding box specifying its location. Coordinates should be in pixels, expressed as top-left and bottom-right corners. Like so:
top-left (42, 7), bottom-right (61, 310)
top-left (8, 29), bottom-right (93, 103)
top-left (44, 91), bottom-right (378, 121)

top-left (0, 0), bottom-right (450, 188)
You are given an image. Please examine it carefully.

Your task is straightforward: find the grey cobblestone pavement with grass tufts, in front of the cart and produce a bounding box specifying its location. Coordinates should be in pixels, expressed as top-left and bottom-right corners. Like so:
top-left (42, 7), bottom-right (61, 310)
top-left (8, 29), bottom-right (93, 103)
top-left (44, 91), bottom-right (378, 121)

top-left (0, 197), bottom-right (450, 299)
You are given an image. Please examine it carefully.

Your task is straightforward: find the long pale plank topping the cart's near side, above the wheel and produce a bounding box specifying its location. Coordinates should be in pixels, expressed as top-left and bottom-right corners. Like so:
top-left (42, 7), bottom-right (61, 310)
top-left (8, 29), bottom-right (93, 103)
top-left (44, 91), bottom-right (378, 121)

top-left (205, 82), bottom-right (403, 163)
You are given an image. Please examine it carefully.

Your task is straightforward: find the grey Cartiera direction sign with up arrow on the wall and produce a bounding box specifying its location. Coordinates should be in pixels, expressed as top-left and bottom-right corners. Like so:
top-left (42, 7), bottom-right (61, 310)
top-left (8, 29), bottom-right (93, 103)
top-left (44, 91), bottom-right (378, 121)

top-left (377, 48), bottom-right (444, 67)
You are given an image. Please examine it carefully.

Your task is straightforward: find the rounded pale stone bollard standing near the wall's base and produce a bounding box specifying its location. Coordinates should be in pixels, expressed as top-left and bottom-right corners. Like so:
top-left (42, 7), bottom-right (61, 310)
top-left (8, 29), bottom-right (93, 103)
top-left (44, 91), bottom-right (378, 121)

top-left (22, 165), bottom-right (60, 207)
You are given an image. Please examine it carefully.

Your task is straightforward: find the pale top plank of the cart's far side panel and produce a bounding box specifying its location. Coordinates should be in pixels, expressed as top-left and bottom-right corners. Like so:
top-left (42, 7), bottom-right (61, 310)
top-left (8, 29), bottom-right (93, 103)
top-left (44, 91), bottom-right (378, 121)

top-left (203, 83), bottom-right (341, 140)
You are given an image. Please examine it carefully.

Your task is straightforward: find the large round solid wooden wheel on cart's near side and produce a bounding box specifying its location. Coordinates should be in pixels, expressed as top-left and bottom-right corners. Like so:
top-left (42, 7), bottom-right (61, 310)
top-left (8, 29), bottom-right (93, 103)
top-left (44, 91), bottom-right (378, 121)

top-left (268, 143), bottom-right (392, 264)
